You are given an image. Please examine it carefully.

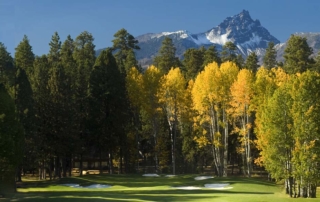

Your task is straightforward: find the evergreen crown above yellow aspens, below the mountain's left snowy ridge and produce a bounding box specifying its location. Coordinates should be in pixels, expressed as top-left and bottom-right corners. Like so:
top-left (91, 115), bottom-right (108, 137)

top-left (153, 37), bottom-right (181, 74)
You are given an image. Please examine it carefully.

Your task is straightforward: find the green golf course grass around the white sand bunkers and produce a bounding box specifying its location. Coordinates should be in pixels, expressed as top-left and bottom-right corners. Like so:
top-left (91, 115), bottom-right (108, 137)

top-left (0, 175), bottom-right (320, 202)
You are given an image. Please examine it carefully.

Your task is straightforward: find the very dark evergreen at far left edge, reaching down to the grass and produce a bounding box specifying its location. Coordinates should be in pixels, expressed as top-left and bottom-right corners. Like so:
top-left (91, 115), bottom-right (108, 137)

top-left (0, 84), bottom-right (24, 196)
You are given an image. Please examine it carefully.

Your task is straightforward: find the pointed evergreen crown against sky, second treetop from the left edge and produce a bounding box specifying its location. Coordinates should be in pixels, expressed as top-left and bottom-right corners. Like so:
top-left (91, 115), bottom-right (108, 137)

top-left (14, 35), bottom-right (34, 75)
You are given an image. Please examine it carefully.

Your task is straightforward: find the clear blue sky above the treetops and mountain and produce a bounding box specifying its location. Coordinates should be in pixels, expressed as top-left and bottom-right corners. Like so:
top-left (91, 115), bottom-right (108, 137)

top-left (0, 0), bottom-right (320, 55)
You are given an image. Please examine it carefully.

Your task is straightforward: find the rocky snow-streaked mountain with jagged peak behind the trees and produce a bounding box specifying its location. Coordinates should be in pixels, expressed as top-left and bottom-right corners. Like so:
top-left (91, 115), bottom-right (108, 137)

top-left (136, 10), bottom-right (280, 67)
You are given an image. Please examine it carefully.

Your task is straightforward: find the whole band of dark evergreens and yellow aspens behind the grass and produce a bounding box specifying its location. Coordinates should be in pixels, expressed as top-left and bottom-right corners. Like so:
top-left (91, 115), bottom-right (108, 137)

top-left (0, 29), bottom-right (320, 197)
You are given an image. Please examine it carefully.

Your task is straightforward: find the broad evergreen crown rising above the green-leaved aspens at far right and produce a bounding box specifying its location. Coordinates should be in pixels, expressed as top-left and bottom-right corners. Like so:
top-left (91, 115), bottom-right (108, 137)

top-left (283, 35), bottom-right (313, 74)
